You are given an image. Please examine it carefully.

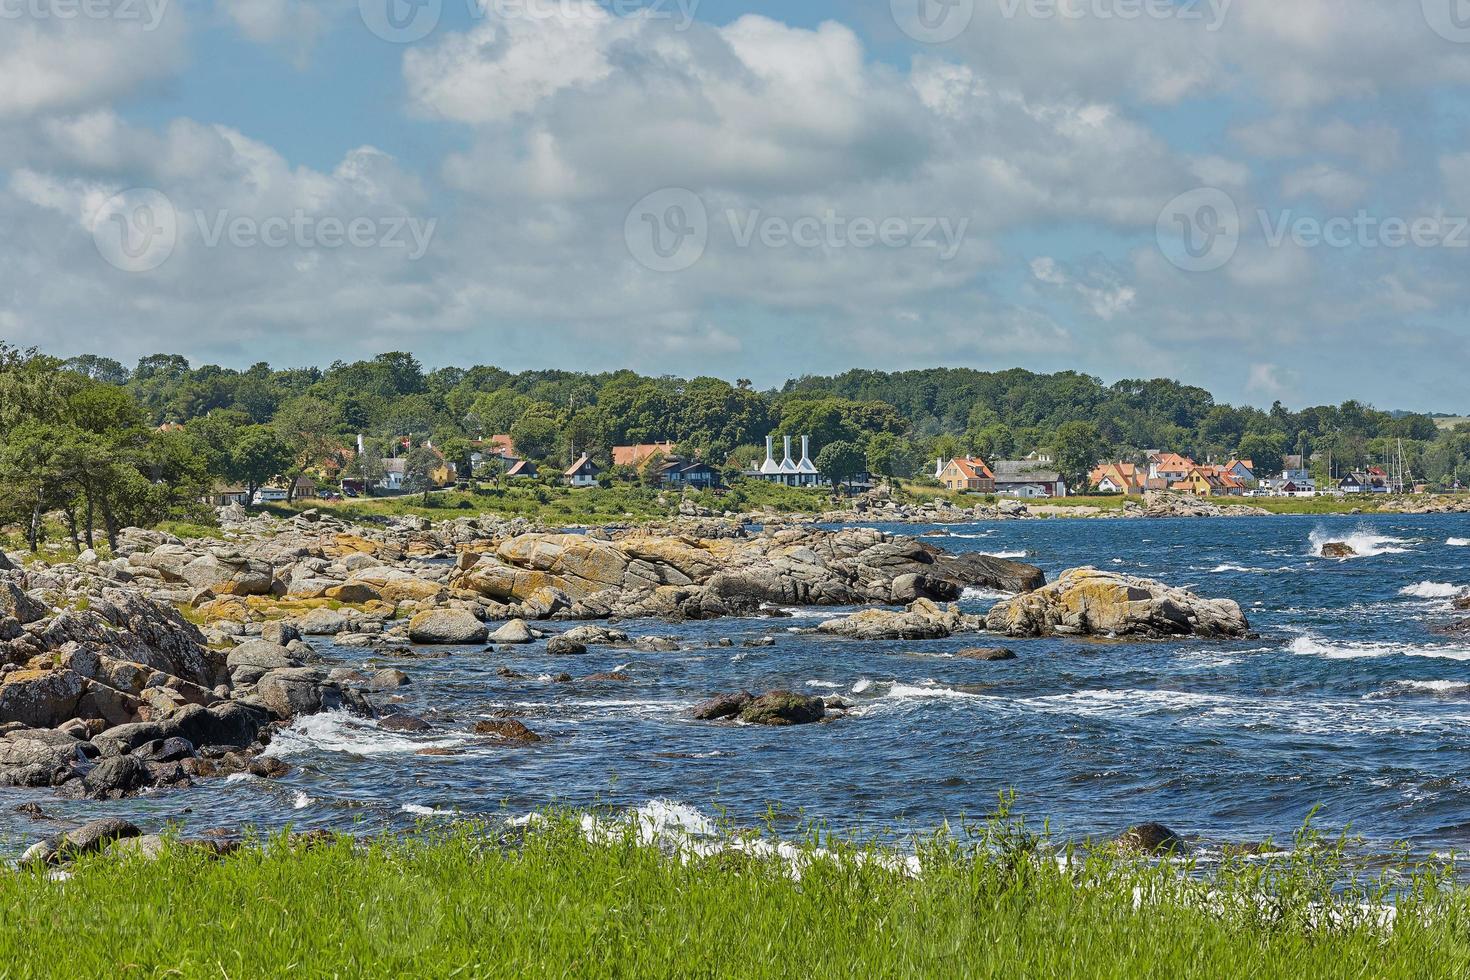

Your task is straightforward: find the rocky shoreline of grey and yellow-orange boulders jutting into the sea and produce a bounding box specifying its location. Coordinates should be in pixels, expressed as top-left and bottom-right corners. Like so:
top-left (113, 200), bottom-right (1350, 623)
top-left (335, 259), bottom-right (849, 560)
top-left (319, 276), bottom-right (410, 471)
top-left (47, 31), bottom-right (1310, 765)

top-left (0, 508), bottom-right (1248, 799)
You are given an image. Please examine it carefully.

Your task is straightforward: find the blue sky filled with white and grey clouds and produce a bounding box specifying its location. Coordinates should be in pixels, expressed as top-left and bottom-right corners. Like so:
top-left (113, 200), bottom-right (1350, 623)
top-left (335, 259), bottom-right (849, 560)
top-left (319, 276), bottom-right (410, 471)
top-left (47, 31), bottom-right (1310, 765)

top-left (0, 0), bottom-right (1470, 414)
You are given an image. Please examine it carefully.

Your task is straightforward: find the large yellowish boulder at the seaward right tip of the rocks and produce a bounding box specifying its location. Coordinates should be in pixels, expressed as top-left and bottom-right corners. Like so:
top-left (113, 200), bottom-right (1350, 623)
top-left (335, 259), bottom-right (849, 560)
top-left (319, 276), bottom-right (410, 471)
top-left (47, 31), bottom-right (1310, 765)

top-left (985, 569), bottom-right (1250, 638)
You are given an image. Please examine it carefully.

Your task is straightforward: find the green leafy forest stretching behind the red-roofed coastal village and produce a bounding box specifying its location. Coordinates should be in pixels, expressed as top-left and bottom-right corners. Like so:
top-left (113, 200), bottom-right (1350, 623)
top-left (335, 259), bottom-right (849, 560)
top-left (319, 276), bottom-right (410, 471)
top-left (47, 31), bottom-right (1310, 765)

top-left (0, 345), bottom-right (1470, 545)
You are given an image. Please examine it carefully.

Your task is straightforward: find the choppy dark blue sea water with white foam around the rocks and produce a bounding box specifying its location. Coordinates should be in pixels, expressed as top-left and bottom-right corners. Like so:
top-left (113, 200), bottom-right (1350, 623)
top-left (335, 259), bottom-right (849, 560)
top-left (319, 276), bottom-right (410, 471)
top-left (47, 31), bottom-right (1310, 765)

top-left (0, 516), bottom-right (1470, 851)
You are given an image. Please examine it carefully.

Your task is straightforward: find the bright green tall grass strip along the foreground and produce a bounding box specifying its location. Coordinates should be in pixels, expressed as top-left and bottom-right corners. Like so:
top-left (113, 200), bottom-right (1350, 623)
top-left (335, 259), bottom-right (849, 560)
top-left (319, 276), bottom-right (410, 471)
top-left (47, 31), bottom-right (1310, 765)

top-left (0, 818), bottom-right (1470, 980)
